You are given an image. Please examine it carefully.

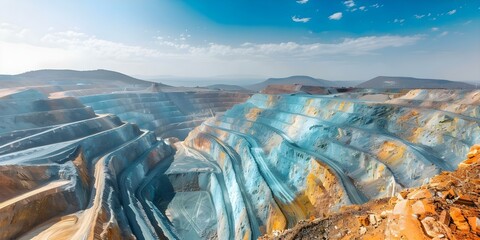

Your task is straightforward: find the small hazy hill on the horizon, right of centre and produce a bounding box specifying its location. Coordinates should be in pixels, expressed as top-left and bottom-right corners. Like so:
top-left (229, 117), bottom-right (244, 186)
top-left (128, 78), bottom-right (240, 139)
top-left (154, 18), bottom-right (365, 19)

top-left (245, 76), bottom-right (338, 91)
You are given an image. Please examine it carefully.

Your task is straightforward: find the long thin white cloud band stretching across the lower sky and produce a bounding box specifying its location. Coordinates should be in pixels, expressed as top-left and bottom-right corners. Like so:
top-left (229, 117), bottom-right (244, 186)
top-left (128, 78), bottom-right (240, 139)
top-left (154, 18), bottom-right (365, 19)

top-left (34, 31), bottom-right (422, 61)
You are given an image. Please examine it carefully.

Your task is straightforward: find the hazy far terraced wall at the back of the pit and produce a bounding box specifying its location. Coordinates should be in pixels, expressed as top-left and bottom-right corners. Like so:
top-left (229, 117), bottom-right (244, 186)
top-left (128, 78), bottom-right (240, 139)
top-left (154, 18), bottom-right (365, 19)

top-left (79, 92), bottom-right (250, 140)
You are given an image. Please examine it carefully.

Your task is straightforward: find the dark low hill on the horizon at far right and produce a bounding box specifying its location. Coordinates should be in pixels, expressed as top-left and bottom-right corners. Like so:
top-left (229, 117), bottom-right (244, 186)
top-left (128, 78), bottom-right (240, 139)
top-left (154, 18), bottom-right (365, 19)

top-left (357, 76), bottom-right (475, 89)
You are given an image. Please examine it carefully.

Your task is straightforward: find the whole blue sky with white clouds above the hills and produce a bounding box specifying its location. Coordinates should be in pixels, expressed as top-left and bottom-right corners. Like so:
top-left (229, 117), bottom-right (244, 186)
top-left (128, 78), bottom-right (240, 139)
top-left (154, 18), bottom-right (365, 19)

top-left (0, 0), bottom-right (480, 81)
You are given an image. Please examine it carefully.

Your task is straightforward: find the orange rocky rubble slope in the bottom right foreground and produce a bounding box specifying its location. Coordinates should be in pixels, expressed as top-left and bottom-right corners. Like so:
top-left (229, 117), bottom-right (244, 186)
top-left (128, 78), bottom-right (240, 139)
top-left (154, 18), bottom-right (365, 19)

top-left (263, 145), bottom-right (480, 239)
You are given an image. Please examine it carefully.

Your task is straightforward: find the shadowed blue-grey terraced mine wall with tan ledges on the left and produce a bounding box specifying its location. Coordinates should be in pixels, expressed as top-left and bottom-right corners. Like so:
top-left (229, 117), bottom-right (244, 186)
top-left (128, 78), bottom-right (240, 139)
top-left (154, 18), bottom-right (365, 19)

top-left (0, 94), bottom-right (174, 239)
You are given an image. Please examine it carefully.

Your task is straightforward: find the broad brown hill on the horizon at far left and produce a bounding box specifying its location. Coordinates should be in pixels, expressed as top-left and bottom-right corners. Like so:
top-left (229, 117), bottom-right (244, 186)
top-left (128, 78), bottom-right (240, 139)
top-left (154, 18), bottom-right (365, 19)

top-left (0, 69), bottom-right (167, 86)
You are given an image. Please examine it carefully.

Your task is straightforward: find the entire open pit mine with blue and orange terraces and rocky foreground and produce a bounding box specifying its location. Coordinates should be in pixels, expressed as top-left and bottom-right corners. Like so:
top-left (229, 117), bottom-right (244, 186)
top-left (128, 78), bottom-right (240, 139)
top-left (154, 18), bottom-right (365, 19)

top-left (0, 74), bottom-right (480, 239)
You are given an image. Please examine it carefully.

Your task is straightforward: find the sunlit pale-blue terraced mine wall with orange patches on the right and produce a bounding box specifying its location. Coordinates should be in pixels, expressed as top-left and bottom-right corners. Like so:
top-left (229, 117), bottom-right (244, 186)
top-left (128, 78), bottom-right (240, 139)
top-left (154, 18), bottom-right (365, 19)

top-left (184, 90), bottom-right (480, 238)
